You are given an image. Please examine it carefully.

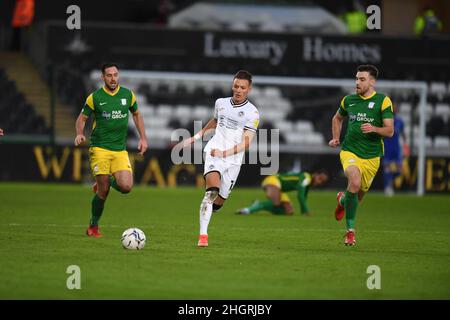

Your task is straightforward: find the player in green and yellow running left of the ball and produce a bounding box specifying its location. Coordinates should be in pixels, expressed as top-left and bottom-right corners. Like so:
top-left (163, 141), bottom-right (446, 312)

top-left (74, 63), bottom-right (148, 238)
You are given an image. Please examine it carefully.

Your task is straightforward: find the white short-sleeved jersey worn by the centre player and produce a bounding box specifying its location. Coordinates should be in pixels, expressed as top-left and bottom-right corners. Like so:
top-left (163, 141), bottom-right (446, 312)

top-left (204, 97), bottom-right (259, 165)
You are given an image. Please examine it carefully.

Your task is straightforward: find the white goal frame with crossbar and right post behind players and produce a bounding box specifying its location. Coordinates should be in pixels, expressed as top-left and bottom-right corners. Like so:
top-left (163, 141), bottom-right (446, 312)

top-left (101, 70), bottom-right (428, 196)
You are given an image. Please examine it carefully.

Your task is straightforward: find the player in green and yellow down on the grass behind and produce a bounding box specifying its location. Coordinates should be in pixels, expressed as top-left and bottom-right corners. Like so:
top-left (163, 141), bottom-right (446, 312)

top-left (236, 170), bottom-right (328, 215)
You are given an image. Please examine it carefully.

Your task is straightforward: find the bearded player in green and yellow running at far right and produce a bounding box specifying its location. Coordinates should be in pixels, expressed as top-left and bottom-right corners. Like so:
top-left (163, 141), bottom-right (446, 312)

top-left (328, 65), bottom-right (394, 246)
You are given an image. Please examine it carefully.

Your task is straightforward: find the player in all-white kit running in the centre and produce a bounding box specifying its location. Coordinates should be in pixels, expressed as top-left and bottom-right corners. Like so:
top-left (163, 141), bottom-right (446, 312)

top-left (180, 70), bottom-right (259, 247)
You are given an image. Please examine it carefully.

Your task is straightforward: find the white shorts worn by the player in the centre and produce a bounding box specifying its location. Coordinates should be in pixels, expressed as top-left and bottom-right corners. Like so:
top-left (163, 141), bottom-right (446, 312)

top-left (203, 154), bottom-right (241, 199)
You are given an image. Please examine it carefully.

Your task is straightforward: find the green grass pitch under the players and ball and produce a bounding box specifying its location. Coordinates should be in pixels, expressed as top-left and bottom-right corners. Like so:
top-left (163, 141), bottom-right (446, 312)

top-left (0, 183), bottom-right (450, 299)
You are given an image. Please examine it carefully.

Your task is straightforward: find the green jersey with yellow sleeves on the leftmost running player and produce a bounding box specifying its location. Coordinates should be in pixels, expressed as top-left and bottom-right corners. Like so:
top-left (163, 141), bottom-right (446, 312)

top-left (81, 86), bottom-right (138, 151)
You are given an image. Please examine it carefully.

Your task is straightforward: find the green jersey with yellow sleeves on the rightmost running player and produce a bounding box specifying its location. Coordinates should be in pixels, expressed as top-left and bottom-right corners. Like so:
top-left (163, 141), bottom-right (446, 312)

top-left (338, 92), bottom-right (394, 159)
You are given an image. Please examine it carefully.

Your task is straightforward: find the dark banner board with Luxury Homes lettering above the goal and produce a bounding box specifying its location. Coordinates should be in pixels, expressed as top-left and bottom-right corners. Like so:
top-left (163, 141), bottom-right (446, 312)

top-left (42, 23), bottom-right (450, 81)
